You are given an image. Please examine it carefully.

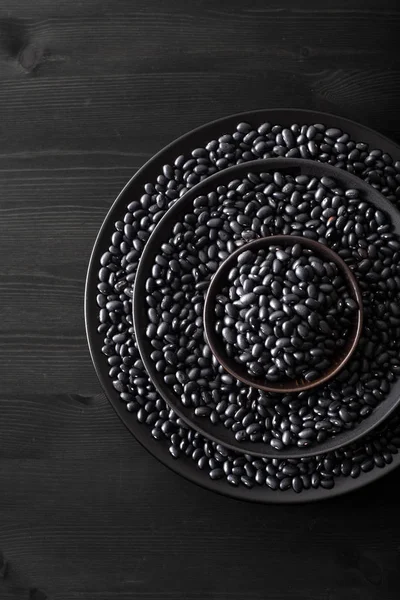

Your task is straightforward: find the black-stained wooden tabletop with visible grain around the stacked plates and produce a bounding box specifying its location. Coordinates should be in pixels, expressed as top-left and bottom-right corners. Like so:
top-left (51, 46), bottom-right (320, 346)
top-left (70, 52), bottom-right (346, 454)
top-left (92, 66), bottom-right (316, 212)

top-left (0, 0), bottom-right (400, 600)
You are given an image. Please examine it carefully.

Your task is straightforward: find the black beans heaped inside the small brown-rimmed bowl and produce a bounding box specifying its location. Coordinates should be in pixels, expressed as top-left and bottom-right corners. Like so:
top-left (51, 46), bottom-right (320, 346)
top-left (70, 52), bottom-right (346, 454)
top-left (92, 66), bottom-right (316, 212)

top-left (215, 243), bottom-right (358, 384)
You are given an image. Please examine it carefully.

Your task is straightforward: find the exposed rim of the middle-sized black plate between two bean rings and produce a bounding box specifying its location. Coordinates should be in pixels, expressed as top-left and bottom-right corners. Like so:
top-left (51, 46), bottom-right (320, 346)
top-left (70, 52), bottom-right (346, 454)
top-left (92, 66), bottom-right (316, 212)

top-left (133, 158), bottom-right (400, 458)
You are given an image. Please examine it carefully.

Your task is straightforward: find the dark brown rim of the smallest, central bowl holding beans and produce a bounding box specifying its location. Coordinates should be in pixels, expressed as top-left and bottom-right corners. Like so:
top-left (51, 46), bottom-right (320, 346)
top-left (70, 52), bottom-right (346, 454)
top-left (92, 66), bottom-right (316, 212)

top-left (203, 235), bottom-right (364, 394)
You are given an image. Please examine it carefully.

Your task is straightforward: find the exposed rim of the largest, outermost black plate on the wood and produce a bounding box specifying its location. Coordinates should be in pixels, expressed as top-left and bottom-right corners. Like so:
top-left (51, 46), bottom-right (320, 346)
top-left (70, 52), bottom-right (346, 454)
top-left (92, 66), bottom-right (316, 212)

top-left (85, 109), bottom-right (400, 503)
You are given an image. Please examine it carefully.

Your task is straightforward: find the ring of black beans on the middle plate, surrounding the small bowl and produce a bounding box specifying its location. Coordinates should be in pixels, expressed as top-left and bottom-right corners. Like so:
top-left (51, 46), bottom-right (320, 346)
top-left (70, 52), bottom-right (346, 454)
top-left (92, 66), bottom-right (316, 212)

top-left (145, 172), bottom-right (400, 450)
